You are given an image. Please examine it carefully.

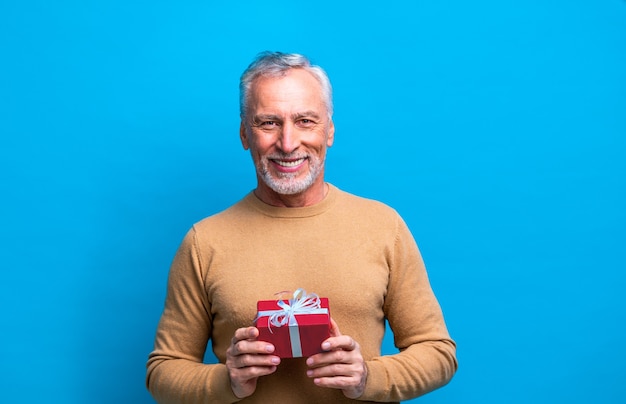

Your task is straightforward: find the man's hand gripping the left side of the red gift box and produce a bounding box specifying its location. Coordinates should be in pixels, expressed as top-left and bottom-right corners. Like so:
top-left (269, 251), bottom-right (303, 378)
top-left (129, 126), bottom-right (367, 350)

top-left (226, 327), bottom-right (280, 398)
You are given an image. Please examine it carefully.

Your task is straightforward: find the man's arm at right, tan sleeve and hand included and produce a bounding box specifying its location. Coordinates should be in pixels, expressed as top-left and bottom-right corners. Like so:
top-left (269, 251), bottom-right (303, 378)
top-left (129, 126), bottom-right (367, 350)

top-left (307, 218), bottom-right (457, 401)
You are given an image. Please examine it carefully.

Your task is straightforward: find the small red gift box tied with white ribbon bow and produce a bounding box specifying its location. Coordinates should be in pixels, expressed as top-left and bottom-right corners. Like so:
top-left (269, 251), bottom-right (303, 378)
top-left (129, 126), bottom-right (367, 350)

top-left (255, 289), bottom-right (330, 358)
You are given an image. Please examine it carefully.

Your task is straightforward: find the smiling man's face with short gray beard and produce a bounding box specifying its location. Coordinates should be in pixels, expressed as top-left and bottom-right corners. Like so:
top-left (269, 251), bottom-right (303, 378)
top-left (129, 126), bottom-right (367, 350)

top-left (240, 69), bottom-right (334, 203)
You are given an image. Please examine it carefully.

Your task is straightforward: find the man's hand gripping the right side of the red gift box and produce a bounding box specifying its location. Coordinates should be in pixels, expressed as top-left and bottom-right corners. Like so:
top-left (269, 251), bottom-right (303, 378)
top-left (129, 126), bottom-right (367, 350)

top-left (306, 319), bottom-right (367, 398)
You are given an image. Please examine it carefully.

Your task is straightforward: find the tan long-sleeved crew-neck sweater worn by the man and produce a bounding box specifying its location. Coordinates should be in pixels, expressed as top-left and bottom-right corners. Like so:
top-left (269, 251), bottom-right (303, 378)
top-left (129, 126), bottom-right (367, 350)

top-left (147, 186), bottom-right (457, 403)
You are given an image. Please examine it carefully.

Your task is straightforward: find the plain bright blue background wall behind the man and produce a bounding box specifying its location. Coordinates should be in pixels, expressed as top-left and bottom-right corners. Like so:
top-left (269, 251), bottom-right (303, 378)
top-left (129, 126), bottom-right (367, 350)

top-left (0, 0), bottom-right (626, 403)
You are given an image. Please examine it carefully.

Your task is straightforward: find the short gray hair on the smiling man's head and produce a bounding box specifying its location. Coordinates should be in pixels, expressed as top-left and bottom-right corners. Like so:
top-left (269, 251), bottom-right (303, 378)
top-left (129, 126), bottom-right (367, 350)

top-left (239, 51), bottom-right (333, 119)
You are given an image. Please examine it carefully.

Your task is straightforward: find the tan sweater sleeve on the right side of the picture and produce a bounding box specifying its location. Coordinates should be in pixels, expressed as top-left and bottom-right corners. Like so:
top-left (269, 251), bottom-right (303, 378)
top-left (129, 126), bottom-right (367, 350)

top-left (360, 216), bottom-right (457, 401)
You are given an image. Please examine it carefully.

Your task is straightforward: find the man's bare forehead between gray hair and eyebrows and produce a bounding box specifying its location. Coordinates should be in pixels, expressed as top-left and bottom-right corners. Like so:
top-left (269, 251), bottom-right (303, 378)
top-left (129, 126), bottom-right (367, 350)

top-left (248, 69), bottom-right (326, 113)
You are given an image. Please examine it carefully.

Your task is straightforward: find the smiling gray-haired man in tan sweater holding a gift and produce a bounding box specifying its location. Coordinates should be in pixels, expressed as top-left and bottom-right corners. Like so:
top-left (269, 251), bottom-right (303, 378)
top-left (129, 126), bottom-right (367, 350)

top-left (147, 52), bottom-right (457, 403)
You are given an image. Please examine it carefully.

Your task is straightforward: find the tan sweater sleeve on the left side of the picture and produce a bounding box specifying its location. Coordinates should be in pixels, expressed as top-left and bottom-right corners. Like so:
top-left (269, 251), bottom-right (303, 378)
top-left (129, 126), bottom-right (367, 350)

top-left (146, 229), bottom-right (238, 404)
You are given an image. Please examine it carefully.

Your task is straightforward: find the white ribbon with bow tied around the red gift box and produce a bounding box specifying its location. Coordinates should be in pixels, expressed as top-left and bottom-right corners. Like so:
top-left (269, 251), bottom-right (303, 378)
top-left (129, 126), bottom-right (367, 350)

top-left (255, 288), bottom-right (328, 358)
